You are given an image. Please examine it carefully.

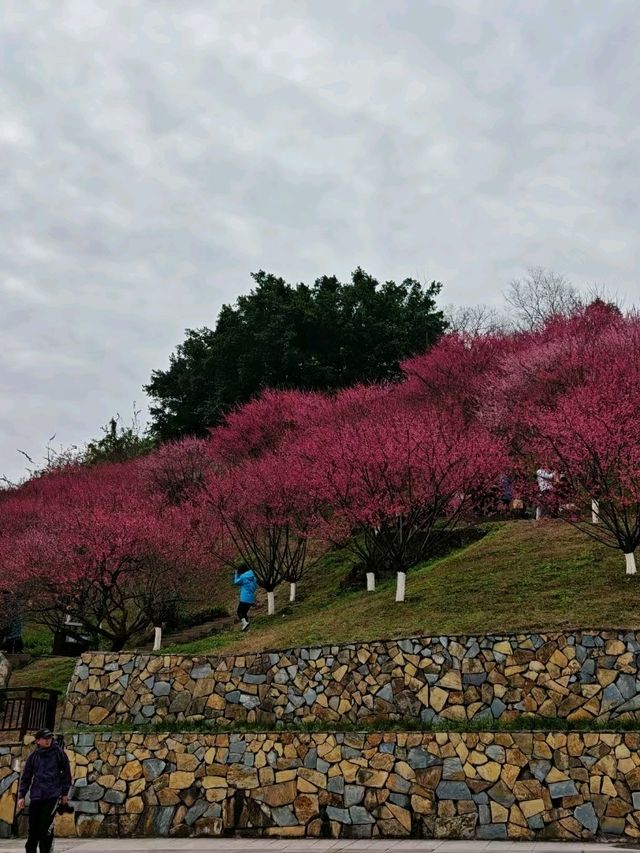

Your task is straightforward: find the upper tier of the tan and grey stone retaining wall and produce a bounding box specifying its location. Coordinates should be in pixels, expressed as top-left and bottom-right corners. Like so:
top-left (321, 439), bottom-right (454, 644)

top-left (64, 630), bottom-right (640, 725)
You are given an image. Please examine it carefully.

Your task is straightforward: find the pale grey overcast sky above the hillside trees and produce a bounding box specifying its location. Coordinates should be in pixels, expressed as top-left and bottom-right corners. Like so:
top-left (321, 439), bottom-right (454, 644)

top-left (0, 0), bottom-right (640, 478)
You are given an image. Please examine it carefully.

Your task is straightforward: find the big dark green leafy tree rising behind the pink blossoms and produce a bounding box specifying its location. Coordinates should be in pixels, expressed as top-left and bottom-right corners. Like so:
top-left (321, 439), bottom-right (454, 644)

top-left (145, 268), bottom-right (446, 440)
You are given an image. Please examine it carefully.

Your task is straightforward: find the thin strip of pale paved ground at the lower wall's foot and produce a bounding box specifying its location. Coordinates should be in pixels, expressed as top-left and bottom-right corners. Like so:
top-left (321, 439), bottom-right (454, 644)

top-left (0, 838), bottom-right (637, 853)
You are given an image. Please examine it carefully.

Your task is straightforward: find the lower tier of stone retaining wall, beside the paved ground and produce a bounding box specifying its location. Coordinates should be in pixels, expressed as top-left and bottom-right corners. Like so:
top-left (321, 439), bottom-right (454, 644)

top-left (5, 732), bottom-right (640, 840)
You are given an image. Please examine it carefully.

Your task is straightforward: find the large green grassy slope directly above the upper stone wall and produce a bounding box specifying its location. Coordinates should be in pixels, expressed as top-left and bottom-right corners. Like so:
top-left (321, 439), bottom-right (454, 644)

top-left (164, 521), bottom-right (640, 653)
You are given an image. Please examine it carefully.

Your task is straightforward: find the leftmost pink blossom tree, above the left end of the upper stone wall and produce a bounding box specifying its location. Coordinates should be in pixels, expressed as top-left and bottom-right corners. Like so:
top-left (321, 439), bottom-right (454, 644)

top-left (0, 463), bottom-right (195, 650)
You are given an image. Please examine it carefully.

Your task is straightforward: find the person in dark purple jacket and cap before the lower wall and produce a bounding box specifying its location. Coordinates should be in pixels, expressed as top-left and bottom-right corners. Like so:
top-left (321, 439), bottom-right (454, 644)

top-left (18, 729), bottom-right (71, 853)
